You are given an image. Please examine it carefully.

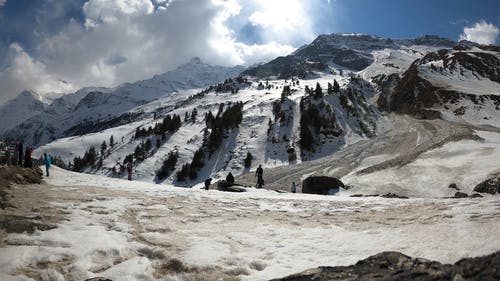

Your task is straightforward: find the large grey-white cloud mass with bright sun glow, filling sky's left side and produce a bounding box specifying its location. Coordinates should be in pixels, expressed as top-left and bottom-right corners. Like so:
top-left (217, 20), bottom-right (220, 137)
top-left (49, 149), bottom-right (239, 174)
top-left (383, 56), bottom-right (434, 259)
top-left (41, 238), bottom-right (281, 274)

top-left (0, 0), bottom-right (323, 103)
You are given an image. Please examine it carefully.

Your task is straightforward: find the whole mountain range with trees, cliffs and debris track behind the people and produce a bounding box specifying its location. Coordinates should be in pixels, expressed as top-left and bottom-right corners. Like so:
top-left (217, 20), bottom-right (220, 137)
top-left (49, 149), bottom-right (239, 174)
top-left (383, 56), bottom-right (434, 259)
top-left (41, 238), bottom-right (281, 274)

top-left (7, 34), bottom-right (500, 197)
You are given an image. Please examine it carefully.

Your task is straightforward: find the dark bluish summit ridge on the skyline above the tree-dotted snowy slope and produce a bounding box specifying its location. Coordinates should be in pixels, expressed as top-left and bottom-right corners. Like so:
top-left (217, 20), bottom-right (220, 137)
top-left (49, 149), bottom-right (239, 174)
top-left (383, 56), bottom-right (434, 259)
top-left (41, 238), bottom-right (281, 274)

top-left (244, 34), bottom-right (457, 79)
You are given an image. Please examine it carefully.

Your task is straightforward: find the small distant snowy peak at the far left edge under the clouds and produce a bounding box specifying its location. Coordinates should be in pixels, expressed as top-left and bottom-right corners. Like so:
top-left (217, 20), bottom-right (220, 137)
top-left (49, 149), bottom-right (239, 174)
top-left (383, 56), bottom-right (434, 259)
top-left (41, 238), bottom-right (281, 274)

top-left (0, 91), bottom-right (49, 135)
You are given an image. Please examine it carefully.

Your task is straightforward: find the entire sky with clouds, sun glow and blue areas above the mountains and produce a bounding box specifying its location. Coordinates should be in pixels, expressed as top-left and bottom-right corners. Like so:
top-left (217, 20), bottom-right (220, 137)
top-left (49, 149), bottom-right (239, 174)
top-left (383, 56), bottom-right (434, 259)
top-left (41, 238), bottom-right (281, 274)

top-left (0, 0), bottom-right (500, 103)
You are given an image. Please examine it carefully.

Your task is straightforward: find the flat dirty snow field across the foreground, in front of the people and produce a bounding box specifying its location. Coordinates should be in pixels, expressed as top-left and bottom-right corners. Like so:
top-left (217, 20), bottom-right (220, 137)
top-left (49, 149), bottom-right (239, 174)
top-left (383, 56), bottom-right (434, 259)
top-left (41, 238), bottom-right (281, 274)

top-left (0, 167), bottom-right (500, 281)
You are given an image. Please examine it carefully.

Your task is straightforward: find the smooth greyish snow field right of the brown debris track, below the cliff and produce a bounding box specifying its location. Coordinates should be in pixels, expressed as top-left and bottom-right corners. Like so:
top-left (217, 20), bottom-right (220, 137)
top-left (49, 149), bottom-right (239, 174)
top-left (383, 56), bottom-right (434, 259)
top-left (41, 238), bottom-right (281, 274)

top-left (342, 131), bottom-right (500, 198)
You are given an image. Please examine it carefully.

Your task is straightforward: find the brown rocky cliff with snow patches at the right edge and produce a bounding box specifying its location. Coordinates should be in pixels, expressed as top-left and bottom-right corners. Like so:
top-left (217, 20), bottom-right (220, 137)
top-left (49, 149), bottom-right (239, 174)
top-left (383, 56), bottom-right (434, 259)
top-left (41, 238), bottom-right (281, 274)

top-left (376, 46), bottom-right (500, 119)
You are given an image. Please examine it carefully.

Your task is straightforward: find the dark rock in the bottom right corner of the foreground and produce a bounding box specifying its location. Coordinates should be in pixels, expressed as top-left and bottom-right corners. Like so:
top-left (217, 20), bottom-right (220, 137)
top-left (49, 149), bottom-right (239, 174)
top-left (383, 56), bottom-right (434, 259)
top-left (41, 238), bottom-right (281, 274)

top-left (274, 249), bottom-right (500, 281)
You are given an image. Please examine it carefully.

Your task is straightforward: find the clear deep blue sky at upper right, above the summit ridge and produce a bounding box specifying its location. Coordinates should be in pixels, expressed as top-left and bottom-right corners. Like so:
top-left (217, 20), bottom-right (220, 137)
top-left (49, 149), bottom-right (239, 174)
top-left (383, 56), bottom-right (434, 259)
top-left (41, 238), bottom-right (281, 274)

top-left (324, 0), bottom-right (500, 40)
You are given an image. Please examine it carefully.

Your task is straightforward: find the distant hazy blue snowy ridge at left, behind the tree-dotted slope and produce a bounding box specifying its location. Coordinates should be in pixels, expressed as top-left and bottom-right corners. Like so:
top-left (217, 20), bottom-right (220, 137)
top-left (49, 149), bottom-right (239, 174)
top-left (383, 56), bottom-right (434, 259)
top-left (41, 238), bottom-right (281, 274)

top-left (4, 58), bottom-right (243, 147)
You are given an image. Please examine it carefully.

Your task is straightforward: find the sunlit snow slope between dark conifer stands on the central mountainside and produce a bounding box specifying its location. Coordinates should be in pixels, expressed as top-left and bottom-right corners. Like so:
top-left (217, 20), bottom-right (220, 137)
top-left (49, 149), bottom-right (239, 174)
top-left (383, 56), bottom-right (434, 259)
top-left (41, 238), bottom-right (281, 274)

top-left (35, 72), bottom-right (384, 186)
